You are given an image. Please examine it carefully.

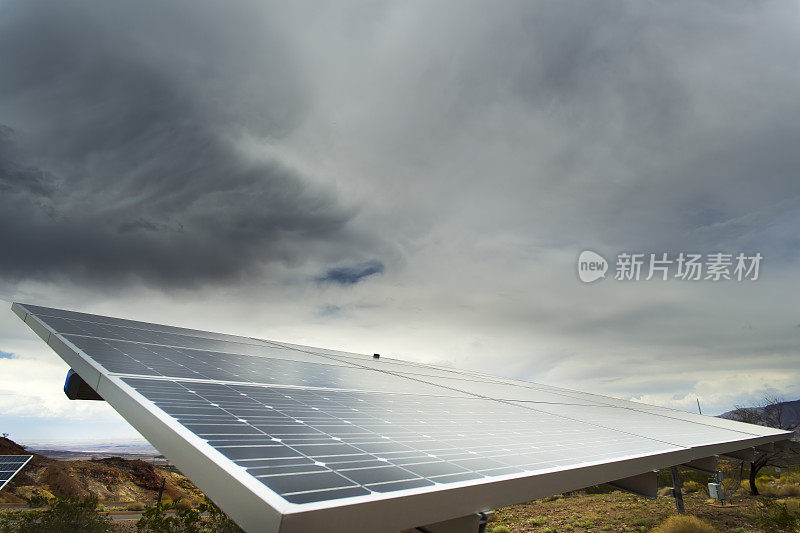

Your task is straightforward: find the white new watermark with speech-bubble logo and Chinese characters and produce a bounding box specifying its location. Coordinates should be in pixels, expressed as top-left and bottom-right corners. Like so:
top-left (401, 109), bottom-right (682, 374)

top-left (577, 250), bottom-right (764, 283)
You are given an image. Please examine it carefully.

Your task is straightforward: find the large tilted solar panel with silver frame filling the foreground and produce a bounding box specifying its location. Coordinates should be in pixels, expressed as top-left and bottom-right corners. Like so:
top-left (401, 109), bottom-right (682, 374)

top-left (13, 304), bottom-right (790, 532)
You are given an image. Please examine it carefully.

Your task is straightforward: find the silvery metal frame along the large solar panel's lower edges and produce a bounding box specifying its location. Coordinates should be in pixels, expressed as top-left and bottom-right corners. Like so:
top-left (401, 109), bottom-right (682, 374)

top-left (12, 303), bottom-right (792, 533)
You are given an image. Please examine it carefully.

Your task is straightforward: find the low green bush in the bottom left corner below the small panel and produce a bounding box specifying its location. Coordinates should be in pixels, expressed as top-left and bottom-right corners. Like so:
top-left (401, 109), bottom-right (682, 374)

top-left (0, 496), bottom-right (112, 533)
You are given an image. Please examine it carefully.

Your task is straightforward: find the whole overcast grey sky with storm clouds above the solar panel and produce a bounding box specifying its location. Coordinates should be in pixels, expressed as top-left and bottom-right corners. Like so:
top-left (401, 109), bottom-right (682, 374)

top-left (0, 0), bottom-right (800, 440)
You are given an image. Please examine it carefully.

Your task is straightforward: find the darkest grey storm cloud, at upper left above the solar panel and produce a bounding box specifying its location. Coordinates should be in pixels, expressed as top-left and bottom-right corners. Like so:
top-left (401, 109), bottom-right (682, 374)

top-left (0, 1), bottom-right (368, 286)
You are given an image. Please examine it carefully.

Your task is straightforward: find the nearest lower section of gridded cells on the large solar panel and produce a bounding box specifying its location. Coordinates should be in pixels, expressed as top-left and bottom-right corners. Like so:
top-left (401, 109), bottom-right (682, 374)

top-left (123, 378), bottom-right (679, 502)
